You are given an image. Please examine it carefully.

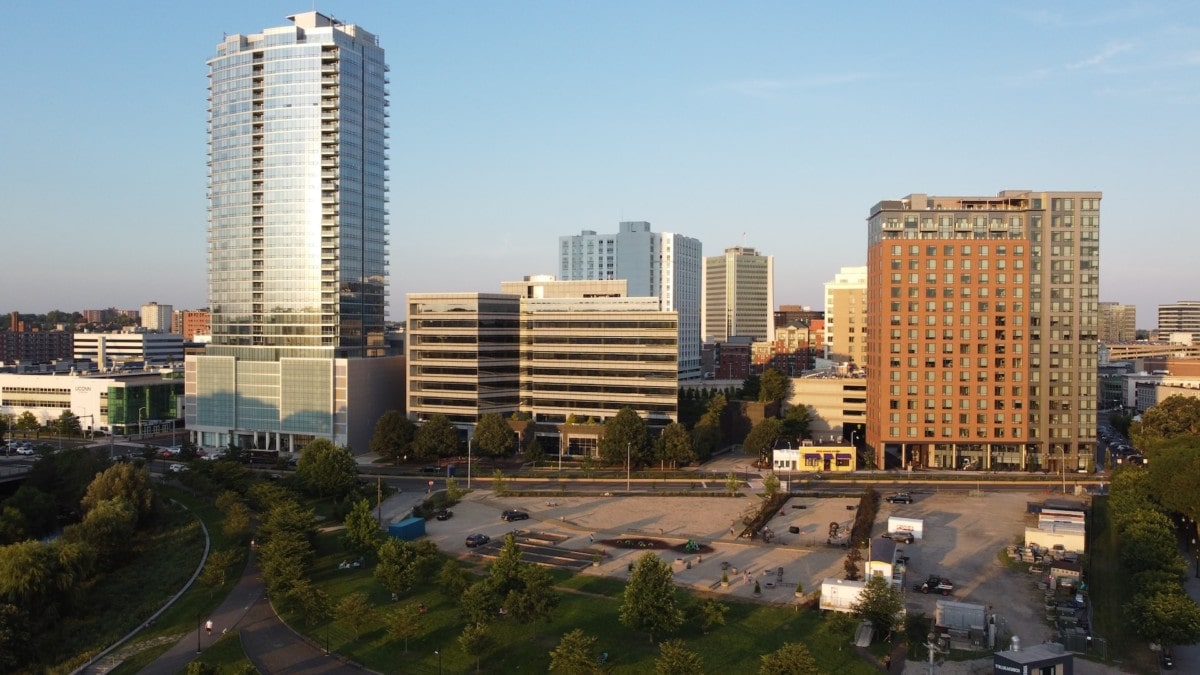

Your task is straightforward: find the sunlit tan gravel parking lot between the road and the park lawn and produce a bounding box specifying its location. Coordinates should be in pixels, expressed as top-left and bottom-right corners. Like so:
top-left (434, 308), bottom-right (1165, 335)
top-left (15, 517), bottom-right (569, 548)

top-left (408, 482), bottom-right (1070, 644)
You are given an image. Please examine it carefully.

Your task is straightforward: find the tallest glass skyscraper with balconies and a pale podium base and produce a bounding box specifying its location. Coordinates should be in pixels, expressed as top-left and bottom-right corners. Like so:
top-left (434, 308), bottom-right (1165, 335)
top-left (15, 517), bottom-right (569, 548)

top-left (185, 12), bottom-right (388, 449)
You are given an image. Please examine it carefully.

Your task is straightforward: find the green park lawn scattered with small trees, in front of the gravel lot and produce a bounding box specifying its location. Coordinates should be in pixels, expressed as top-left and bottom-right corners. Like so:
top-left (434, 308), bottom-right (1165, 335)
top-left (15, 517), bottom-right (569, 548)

top-left (280, 533), bottom-right (875, 674)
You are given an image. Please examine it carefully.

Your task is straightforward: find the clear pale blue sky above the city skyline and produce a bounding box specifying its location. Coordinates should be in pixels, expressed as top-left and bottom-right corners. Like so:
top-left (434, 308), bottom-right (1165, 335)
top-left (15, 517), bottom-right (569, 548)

top-left (0, 0), bottom-right (1200, 327)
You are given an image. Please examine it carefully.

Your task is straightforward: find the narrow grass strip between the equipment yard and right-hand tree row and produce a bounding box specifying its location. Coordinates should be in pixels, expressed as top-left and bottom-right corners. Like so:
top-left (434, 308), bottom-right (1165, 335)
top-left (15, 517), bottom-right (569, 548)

top-left (1087, 497), bottom-right (1158, 673)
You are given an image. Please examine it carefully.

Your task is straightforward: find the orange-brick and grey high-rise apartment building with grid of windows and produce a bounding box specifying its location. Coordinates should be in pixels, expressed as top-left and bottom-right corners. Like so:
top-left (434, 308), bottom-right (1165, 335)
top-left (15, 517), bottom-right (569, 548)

top-left (866, 190), bottom-right (1100, 472)
